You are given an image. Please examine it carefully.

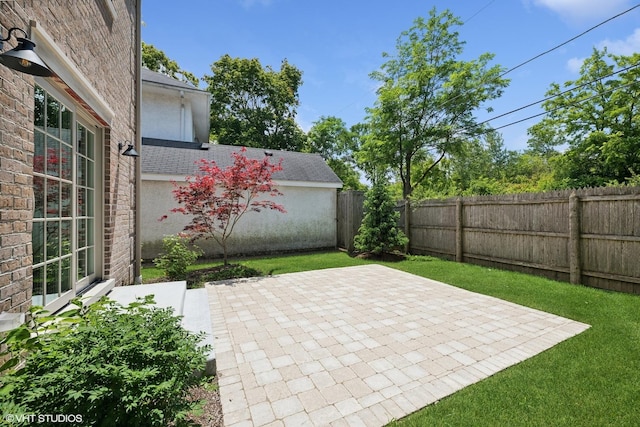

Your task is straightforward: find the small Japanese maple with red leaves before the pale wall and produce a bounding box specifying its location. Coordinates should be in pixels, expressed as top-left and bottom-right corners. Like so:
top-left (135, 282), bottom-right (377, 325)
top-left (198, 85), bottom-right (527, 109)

top-left (161, 147), bottom-right (286, 265)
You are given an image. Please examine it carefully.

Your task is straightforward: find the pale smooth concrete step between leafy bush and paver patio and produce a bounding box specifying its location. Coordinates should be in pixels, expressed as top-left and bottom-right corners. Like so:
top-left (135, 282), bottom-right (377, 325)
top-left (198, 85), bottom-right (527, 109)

top-left (107, 281), bottom-right (216, 375)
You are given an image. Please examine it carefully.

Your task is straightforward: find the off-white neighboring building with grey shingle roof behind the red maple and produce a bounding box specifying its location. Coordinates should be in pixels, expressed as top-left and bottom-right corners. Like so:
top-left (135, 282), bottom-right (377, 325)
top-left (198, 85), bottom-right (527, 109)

top-left (140, 69), bottom-right (342, 260)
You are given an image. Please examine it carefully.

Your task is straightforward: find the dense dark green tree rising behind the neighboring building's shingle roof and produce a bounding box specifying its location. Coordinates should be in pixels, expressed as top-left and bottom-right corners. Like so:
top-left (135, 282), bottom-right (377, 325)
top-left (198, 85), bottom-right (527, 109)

top-left (203, 55), bottom-right (305, 151)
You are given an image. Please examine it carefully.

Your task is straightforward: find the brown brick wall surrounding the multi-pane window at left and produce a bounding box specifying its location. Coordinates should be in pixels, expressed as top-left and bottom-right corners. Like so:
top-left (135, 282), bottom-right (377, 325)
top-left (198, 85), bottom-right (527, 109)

top-left (0, 0), bottom-right (141, 312)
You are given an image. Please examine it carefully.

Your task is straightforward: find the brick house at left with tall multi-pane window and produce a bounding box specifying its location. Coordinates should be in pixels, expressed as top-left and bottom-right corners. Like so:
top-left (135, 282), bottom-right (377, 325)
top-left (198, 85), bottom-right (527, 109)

top-left (0, 0), bottom-right (141, 317)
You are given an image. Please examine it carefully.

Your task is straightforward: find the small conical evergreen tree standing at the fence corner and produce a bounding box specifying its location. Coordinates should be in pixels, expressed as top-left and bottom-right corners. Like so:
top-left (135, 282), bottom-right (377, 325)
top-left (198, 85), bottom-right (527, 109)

top-left (354, 180), bottom-right (409, 255)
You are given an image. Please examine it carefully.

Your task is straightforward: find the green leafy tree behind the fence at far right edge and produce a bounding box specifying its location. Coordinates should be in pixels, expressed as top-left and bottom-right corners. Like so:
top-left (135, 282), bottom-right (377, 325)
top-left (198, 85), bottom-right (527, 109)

top-left (529, 49), bottom-right (640, 188)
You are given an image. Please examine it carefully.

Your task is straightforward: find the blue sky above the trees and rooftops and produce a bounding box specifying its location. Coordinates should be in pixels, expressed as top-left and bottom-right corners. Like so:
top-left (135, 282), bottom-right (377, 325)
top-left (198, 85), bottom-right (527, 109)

top-left (142, 0), bottom-right (640, 150)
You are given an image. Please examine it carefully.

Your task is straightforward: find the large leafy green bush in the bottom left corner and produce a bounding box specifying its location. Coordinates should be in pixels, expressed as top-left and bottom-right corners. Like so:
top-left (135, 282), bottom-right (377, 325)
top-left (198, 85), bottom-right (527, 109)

top-left (0, 297), bottom-right (208, 426)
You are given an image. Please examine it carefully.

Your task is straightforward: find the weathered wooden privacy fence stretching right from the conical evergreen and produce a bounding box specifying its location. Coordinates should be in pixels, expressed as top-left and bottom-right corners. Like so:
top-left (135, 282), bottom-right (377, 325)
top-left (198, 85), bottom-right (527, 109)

top-left (339, 187), bottom-right (640, 294)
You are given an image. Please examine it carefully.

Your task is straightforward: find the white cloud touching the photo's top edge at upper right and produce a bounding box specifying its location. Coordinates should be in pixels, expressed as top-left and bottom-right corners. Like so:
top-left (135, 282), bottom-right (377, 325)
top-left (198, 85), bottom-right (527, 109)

top-left (533, 0), bottom-right (630, 22)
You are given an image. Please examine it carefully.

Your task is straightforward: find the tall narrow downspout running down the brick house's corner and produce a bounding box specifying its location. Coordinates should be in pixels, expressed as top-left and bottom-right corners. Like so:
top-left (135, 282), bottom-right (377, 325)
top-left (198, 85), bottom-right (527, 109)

top-left (133, 0), bottom-right (142, 284)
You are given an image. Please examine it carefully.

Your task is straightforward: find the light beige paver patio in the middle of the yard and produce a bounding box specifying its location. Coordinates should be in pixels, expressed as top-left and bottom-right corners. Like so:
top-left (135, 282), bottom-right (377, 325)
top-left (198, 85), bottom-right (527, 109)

top-left (207, 265), bottom-right (589, 427)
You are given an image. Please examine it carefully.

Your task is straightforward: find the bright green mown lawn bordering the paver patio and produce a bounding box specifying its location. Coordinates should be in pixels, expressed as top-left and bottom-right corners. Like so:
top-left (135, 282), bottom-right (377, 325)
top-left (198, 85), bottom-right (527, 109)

top-left (143, 252), bottom-right (640, 427)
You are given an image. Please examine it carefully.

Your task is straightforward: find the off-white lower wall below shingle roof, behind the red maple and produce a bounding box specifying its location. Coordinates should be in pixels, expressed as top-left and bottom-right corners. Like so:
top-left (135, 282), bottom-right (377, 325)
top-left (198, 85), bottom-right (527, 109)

top-left (141, 180), bottom-right (336, 260)
